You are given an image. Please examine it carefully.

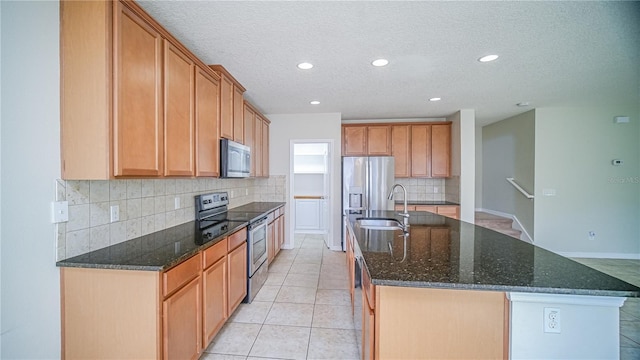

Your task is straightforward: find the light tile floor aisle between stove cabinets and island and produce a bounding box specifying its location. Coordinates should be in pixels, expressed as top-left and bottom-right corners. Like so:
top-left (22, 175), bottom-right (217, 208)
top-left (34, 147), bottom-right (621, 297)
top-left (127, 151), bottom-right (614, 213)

top-left (200, 234), bottom-right (358, 360)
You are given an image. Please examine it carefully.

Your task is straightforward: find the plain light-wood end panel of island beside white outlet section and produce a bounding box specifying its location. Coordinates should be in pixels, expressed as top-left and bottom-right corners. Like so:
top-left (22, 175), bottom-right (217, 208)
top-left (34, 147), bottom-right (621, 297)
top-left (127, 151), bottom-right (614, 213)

top-left (376, 286), bottom-right (509, 359)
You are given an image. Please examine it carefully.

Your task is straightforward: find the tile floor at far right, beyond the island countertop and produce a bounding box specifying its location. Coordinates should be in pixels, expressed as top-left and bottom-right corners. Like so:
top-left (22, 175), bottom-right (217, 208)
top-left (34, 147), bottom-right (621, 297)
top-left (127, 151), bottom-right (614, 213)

top-left (574, 259), bottom-right (640, 360)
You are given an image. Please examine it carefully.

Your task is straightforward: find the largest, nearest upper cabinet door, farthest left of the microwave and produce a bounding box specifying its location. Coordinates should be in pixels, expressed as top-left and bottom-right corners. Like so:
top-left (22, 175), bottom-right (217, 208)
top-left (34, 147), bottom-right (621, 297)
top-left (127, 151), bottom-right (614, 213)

top-left (113, 2), bottom-right (164, 176)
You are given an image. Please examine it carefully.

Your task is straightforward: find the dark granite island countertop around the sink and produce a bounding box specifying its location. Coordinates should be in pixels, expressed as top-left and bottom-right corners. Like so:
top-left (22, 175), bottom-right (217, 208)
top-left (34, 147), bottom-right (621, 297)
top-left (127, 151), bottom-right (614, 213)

top-left (349, 211), bottom-right (640, 297)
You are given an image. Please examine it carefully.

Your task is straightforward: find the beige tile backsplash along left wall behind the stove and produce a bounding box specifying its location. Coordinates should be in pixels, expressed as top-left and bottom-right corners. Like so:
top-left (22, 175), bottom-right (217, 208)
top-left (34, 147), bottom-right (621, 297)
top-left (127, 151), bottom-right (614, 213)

top-left (56, 176), bottom-right (287, 260)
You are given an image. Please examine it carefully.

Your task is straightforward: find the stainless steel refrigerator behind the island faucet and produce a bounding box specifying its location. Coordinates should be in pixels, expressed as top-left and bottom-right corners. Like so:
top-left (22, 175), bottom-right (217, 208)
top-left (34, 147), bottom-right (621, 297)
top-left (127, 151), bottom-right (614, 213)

top-left (342, 156), bottom-right (395, 250)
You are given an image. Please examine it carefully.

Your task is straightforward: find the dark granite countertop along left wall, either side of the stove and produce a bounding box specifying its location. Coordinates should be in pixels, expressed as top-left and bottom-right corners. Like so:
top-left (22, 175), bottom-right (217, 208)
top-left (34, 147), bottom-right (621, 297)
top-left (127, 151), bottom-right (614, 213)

top-left (56, 202), bottom-right (285, 271)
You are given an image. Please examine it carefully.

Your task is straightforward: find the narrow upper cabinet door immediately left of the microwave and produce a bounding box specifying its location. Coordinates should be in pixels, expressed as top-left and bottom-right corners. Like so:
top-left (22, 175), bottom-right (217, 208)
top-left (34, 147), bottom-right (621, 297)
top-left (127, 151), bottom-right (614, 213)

top-left (195, 67), bottom-right (220, 176)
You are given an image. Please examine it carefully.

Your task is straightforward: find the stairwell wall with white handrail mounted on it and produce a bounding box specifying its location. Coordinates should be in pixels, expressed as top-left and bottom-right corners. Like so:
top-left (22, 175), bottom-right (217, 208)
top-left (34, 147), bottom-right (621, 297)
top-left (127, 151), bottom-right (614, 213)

top-left (482, 110), bottom-right (540, 237)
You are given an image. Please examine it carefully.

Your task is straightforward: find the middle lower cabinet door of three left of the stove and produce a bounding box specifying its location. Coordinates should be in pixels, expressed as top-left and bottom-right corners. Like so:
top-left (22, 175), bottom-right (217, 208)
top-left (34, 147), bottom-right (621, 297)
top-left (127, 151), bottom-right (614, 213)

top-left (202, 256), bottom-right (228, 348)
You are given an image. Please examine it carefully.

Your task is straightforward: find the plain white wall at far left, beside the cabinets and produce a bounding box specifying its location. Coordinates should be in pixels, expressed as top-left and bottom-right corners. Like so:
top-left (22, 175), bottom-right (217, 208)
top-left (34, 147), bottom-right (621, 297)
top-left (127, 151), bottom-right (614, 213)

top-left (0, 1), bottom-right (60, 359)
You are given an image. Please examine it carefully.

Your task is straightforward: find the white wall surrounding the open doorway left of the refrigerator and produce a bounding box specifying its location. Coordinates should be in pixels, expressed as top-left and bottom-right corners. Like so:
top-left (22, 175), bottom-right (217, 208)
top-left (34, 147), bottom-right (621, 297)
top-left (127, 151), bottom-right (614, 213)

top-left (267, 113), bottom-right (342, 249)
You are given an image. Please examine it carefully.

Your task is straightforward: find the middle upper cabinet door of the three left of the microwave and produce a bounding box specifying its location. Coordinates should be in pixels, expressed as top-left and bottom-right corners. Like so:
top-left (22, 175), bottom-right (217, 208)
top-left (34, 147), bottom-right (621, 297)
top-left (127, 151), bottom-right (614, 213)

top-left (164, 40), bottom-right (195, 176)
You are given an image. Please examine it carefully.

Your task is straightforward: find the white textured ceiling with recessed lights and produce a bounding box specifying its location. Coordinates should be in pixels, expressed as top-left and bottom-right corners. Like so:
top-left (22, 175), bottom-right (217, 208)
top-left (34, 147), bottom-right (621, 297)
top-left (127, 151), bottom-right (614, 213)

top-left (140, 1), bottom-right (640, 124)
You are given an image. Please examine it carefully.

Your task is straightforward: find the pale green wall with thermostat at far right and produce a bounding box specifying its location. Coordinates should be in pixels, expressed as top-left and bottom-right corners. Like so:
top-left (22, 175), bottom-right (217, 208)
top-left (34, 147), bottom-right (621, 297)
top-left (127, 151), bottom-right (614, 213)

top-left (535, 105), bottom-right (640, 258)
